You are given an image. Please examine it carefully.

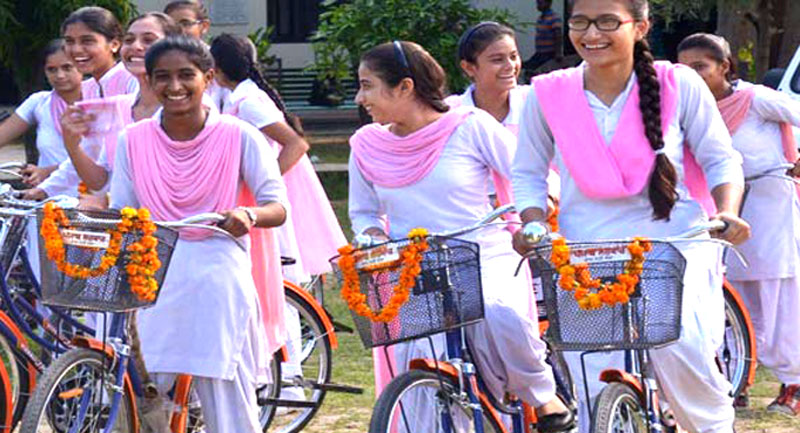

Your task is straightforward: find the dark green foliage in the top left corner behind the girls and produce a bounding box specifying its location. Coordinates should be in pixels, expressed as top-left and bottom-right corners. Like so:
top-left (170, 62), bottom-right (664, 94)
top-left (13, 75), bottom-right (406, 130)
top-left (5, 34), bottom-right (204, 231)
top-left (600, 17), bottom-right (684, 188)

top-left (0, 0), bottom-right (136, 94)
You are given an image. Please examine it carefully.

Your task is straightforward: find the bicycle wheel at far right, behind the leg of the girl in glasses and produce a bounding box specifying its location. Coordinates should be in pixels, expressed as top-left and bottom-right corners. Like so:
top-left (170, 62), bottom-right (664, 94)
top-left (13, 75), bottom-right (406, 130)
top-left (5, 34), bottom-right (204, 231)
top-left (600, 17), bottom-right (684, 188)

top-left (717, 290), bottom-right (757, 398)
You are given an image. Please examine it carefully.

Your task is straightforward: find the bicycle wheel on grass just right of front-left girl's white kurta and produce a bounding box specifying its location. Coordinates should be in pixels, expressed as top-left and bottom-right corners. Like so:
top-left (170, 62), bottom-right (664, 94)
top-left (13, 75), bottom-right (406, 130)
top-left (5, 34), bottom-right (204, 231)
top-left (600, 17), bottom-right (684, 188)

top-left (262, 290), bottom-right (333, 433)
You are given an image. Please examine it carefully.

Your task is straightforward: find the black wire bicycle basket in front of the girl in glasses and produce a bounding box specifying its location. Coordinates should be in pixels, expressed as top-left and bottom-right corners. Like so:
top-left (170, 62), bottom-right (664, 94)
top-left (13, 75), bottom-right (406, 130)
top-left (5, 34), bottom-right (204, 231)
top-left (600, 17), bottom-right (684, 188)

top-left (529, 242), bottom-right (686, 351)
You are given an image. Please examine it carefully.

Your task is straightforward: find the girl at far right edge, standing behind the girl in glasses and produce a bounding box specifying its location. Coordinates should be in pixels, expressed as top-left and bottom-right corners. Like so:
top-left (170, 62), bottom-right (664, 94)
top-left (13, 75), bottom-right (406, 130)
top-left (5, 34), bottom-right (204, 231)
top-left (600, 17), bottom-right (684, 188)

top-left (678, 33), bottom-right (800, 416)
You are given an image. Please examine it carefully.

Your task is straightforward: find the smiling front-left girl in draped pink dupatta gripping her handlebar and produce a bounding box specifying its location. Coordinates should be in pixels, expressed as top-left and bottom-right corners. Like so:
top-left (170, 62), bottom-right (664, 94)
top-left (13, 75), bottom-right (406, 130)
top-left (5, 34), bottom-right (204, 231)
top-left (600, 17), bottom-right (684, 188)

top-left (111, 36), bottom-right (286, 433)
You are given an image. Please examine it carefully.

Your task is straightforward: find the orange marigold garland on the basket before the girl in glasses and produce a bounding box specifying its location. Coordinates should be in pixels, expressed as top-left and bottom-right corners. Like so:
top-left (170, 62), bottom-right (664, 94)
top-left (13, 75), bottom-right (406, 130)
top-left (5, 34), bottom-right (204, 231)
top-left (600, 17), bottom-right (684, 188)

top-left (550, 238), bottom-right (653, 310)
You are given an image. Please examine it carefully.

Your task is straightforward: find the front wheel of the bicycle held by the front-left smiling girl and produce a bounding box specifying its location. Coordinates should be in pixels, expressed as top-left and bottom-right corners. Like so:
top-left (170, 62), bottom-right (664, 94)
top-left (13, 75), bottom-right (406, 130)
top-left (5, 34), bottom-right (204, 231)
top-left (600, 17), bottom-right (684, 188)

top-left (20, 349), bottom-right (136, 433)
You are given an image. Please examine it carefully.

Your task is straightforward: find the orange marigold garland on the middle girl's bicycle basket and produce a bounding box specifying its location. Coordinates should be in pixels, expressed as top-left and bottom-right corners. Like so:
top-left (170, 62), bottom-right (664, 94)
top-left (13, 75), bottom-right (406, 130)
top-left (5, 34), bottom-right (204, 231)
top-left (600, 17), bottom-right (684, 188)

top-left (339, 228), bottom-right (428, 323)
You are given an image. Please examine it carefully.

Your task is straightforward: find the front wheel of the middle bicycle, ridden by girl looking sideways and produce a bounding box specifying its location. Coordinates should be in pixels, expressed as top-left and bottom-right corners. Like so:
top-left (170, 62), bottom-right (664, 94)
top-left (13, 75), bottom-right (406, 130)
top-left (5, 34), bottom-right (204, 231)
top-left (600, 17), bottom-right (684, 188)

top-left (369, 370), bottom-right (504, 433)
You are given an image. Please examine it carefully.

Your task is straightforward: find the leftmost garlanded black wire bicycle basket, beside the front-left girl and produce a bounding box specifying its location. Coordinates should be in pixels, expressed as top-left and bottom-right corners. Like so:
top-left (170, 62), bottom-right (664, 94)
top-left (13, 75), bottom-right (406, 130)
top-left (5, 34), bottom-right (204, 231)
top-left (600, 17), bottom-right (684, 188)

top-left (37, 209), bottom-right (178, 312)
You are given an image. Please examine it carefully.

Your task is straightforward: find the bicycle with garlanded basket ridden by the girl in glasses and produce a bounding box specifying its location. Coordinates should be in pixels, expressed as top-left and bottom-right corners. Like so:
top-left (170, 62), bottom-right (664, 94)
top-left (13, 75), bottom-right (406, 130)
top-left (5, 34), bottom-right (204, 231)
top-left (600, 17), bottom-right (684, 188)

top-left (525, 221), bottom-right (727, 433)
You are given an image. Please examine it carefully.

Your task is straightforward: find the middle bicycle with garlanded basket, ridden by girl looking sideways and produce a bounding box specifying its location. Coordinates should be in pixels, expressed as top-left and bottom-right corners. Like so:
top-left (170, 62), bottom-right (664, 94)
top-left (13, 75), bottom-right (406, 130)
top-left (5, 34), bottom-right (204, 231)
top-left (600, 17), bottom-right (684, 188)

top-left (332, 205), bottom-right (574, 433)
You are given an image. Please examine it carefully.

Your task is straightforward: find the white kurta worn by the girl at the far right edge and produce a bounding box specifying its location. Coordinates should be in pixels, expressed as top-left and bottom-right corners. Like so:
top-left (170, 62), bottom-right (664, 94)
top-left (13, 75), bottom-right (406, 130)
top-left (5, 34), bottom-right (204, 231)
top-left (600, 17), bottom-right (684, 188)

top-left (727, 81), bottom-right (800, 280)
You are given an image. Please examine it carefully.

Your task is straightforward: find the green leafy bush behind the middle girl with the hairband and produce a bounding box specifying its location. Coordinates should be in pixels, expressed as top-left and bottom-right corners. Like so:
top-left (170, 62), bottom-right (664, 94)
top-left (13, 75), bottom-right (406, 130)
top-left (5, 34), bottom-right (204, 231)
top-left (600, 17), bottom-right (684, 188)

top-left (312, 0), bottom-right (515, 90)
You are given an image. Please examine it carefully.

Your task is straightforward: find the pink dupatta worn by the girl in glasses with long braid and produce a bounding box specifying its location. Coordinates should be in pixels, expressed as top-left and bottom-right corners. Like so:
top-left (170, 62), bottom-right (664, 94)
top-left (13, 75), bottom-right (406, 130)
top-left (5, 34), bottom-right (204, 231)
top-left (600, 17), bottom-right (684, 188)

top-left (533, 61), bottom-right (713, 213)
